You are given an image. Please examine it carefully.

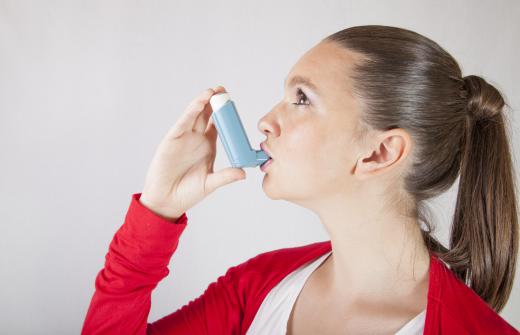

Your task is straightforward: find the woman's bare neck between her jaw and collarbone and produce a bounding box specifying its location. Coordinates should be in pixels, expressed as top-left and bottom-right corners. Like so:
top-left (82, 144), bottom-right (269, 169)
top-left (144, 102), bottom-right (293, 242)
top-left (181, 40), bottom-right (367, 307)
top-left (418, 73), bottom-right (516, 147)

top-left (306, 192), bottom-right (430, 305)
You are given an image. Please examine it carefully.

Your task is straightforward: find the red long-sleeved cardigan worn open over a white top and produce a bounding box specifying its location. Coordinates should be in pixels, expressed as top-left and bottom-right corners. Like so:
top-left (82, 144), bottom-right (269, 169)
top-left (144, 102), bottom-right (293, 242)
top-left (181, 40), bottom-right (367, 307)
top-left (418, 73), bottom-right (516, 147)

top-left (82, 193), bottom-right (519, 335)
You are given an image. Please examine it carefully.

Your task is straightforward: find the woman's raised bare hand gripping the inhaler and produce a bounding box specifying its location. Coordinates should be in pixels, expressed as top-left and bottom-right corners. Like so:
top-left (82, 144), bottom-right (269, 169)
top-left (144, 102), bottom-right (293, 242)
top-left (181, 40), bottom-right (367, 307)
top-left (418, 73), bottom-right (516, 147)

top-left (139, 86), bottom-right (246, 220)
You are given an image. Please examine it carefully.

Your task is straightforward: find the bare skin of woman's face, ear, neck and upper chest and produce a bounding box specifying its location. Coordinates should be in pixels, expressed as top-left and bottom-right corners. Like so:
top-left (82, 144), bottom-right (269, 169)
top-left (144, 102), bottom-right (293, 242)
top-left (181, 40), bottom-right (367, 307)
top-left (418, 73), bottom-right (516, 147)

top-left (258, 42), bottom-right (429, 334)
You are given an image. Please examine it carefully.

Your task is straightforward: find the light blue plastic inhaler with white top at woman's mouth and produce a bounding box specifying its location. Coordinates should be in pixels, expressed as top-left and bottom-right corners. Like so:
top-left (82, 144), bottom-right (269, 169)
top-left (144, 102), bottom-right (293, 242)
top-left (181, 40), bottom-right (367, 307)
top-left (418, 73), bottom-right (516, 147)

top-left (209, 92), bottom-right (270, 167)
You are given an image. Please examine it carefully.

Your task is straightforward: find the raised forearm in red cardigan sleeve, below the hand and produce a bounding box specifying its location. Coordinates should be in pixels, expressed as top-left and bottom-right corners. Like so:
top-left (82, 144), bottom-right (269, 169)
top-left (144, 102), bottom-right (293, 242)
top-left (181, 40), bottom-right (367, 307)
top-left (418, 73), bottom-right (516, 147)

top-left (82, 194), bottom-right (187, 334)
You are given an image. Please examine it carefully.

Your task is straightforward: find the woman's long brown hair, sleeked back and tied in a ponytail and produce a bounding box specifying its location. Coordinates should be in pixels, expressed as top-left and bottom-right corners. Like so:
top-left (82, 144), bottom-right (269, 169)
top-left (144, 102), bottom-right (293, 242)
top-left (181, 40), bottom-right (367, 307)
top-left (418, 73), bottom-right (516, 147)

top-left (322, 25), bottom-right (518, 312)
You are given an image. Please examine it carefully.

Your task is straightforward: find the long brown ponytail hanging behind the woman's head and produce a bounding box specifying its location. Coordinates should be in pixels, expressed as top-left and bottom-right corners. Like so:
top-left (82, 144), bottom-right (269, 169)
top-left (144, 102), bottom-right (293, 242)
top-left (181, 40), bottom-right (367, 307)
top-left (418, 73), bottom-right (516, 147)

top-left (440, 76), bottom-right (518, 312)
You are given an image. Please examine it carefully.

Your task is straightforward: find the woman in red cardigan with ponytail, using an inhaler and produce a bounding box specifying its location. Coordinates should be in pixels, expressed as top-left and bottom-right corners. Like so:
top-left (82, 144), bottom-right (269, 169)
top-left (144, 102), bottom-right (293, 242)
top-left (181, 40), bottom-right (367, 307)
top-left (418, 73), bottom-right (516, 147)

top-left (83, 25), bottom-right (518, 335)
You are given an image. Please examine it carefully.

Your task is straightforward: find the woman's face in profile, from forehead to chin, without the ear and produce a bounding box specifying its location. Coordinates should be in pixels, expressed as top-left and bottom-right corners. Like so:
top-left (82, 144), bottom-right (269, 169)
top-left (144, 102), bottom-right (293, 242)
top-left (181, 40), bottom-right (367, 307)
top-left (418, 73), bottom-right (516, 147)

top-left (258, 42), bottom-right (368, 205)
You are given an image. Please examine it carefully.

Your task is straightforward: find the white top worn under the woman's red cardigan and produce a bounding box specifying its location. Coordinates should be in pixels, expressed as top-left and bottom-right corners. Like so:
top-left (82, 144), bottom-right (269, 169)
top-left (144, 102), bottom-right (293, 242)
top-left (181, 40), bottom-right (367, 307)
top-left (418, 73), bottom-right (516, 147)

top-left (246, 250), bottom-right (426, 335)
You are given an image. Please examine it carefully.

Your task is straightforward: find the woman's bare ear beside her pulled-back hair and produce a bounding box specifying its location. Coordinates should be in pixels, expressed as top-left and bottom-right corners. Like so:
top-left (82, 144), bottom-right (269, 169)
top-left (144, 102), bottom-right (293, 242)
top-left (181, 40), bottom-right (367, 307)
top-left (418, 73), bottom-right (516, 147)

top-left (354, 128), bottom-right (412, 180)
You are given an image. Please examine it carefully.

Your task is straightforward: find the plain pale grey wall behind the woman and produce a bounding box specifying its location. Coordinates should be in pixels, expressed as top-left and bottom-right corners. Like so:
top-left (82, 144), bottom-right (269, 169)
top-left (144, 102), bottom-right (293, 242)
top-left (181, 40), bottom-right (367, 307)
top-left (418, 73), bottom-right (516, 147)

top-left (0, 0), bottom-right (520, 334)
